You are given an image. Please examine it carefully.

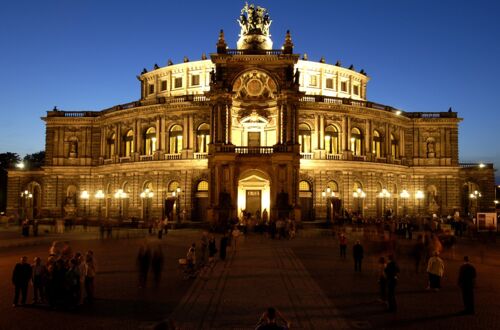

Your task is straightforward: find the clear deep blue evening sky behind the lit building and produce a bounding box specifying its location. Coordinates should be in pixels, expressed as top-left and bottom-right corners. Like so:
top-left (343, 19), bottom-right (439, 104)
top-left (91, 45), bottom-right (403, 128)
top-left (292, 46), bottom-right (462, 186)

top-left (0, 0), bottom-right (500, 182)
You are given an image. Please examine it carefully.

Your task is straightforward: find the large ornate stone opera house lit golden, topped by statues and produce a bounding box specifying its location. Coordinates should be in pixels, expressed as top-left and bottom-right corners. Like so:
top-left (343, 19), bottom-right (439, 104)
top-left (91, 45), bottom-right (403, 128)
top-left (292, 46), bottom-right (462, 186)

top-left (8, 6), bottom-right (494, 222)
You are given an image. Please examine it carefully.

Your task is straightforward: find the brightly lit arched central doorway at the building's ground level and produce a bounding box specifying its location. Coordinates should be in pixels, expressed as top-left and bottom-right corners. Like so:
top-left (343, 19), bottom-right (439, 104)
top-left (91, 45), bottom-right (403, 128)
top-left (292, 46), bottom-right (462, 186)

top-left (238, 170), bottom-right (271, 219)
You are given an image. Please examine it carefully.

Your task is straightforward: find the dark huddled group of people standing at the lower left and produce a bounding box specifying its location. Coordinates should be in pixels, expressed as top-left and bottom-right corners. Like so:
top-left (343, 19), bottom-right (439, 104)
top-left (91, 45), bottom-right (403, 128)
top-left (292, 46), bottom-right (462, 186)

top-left (12, 242), bottom-right (96, 309)
